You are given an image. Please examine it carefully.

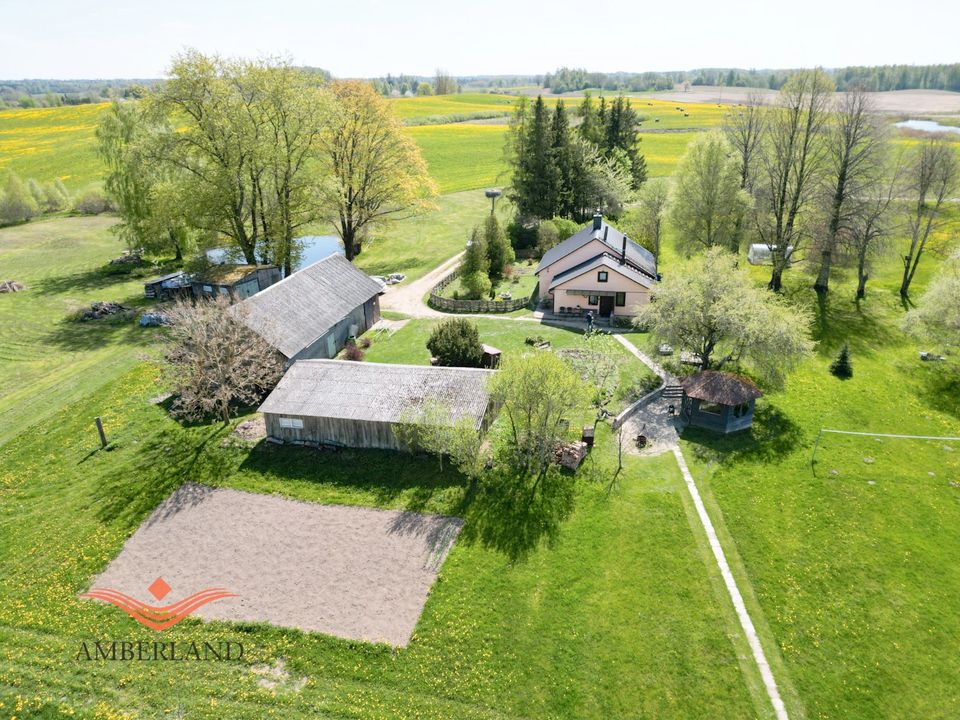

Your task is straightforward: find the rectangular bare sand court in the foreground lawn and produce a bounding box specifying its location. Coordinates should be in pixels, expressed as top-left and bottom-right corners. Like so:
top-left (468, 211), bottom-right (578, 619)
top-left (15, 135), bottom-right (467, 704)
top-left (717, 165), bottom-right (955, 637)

top-left (92, 484), bottom-right (462, 646)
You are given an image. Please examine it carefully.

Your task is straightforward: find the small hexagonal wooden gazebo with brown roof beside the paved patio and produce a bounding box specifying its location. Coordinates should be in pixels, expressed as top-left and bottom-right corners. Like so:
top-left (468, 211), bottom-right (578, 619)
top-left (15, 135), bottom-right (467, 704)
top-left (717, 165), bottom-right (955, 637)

top-left (680, 370), bottom-right (763, 433)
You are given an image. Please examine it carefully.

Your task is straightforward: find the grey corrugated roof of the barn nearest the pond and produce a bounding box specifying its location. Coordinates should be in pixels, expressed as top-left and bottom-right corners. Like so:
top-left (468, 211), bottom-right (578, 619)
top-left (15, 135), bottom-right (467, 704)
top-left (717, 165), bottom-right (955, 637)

top-left (242, 253), bottom-right (382, 358)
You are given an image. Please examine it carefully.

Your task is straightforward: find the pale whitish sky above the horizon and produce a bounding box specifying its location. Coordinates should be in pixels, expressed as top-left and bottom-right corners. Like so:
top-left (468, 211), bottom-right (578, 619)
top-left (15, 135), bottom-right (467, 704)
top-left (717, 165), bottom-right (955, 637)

top-left (0, 0), bottom-right (960, 79)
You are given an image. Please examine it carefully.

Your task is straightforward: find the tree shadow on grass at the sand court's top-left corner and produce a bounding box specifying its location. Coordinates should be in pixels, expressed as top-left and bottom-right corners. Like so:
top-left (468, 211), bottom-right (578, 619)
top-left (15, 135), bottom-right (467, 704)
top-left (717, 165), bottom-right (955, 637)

top-left (93, 425), bottom-right (237, 527)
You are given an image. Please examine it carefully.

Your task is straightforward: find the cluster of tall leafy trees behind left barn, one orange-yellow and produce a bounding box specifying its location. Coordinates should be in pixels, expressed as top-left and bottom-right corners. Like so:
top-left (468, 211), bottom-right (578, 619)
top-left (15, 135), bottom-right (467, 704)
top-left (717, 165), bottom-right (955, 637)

top-left (97, 51), bottom-right (435, 273)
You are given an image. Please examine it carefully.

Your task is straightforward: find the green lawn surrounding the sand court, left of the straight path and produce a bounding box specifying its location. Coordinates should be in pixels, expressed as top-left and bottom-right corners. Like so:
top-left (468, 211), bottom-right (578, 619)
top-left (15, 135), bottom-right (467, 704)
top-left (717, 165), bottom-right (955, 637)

top-left (0, 365), bottom-right (765, 719)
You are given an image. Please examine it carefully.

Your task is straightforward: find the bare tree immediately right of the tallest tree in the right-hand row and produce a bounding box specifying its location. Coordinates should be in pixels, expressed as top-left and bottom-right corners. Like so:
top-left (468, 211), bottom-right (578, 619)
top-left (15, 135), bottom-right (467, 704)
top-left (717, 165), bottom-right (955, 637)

top-left (813, 88), bottom-right (885, 294)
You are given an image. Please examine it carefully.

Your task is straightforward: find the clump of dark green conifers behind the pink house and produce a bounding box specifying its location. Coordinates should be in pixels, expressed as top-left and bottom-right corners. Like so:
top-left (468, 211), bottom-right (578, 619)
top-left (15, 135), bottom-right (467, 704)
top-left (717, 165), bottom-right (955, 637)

top-left (507, 94), bottom-right (647, 222)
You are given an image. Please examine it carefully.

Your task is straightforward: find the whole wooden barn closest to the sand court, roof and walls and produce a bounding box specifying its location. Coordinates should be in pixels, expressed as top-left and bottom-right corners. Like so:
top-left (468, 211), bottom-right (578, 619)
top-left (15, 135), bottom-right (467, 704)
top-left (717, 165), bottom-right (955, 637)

top-left (260, 360), bottom-right (494, 450)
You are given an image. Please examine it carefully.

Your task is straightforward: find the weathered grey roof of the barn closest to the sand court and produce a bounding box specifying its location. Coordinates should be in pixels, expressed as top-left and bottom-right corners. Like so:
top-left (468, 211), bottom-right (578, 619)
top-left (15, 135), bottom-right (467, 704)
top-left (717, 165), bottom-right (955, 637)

top-left (260, 360), bottom-right (494, 427)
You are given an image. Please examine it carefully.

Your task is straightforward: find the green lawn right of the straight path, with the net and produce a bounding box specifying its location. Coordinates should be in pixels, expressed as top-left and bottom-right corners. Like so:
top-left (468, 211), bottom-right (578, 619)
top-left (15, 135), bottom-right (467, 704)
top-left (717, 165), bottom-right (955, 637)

top-left (683, 229), bottom-right (960, 719)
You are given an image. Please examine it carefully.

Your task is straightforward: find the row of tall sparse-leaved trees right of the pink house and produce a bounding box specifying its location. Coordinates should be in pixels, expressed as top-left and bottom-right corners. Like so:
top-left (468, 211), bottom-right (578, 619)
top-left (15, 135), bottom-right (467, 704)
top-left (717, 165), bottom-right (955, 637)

top-left (626, 70), bottom-right (960, 298)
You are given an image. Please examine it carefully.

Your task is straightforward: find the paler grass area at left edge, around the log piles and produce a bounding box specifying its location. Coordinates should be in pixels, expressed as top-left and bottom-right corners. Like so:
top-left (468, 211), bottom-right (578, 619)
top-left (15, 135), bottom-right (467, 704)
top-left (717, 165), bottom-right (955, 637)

top-left (0, 217), bottom-right (159, 444)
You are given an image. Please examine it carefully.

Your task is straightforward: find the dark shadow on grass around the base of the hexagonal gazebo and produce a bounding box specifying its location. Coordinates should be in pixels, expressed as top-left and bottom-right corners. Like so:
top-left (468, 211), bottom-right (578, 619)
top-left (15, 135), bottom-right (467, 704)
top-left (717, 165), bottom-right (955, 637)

top-left (683, 405), bottom-right (803, 462)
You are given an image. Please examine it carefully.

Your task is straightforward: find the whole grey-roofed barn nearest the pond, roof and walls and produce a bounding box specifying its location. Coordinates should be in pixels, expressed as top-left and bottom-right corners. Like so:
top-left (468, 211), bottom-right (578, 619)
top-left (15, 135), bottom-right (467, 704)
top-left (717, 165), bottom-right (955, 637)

top-left (241, 253), bottom-right (382, 362)
